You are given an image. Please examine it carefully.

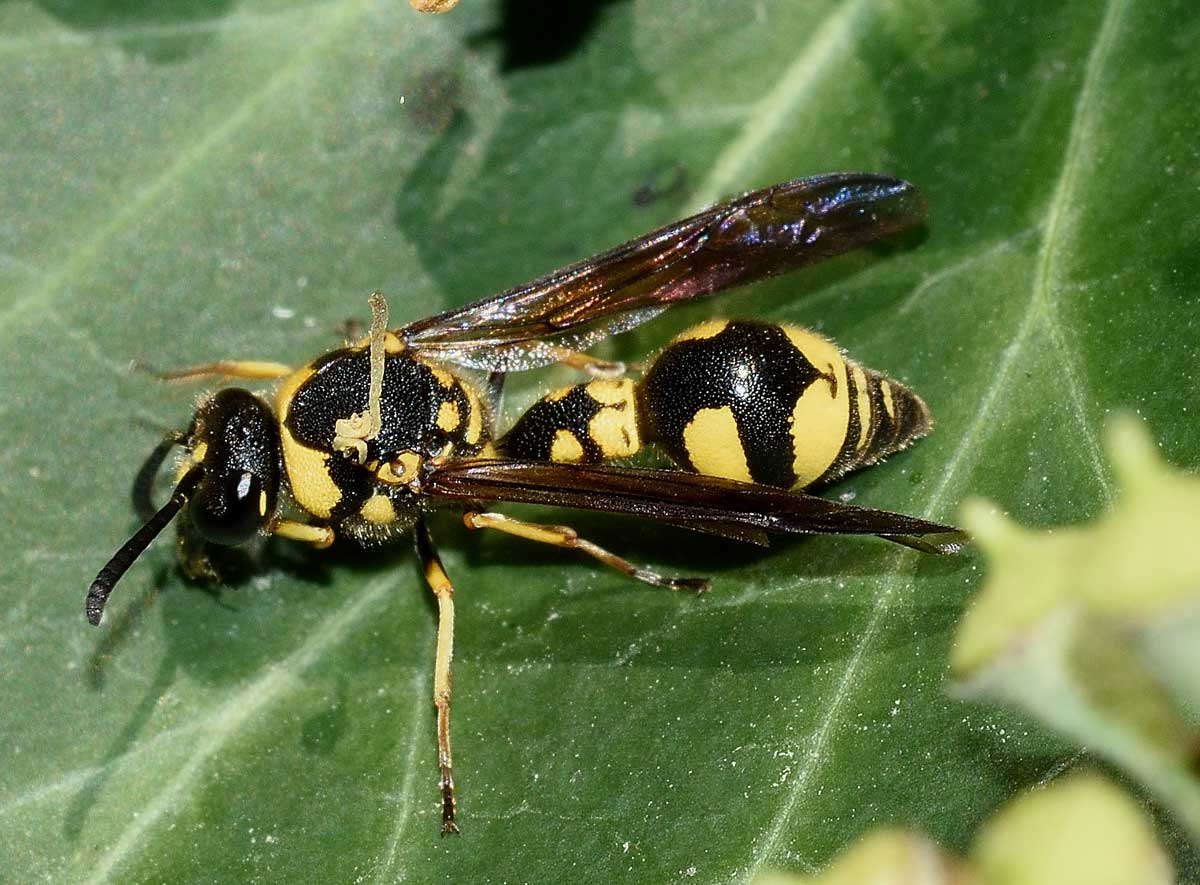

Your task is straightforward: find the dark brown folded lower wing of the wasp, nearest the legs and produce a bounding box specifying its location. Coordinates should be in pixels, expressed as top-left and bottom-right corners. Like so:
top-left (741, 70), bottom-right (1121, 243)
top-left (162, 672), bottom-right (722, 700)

top-left (421, 460), bottom-right (967, 553)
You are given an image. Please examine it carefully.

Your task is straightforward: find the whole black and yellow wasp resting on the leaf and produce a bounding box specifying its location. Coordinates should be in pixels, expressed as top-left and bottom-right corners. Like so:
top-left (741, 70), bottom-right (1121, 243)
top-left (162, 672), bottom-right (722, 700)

top-left (86, 174), bottom-right (964, 831)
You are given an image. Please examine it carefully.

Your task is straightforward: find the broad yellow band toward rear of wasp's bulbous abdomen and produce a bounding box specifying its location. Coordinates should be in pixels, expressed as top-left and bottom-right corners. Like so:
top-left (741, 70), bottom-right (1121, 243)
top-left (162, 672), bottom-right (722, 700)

top-left (780, 324), bottom-right (858, 489)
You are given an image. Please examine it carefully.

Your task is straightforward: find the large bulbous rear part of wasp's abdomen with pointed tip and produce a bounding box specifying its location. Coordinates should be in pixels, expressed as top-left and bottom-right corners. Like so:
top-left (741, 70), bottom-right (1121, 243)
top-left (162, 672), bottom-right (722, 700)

top-left (638, 319), bottom-right (930, 489)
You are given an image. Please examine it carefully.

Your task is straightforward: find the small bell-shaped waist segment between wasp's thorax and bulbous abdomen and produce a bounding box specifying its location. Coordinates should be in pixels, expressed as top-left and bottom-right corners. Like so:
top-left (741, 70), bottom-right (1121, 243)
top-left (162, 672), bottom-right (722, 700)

top-left (498, 378), bottom-right (642, 464)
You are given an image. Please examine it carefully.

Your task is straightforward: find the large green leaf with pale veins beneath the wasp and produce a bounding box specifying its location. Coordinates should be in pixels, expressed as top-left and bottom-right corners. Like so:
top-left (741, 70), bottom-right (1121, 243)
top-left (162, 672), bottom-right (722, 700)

top-left (0, 0), bottom-right (1200, 881)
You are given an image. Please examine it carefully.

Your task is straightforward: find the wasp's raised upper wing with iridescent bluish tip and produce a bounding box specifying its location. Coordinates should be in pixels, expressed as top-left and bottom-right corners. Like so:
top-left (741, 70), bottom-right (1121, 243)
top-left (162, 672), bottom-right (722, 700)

top-left (398, 173), bottom-right (925, 372)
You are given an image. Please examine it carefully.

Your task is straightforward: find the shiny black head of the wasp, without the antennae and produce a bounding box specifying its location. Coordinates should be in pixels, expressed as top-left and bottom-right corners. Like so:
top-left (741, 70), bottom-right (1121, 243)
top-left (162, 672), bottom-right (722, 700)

top-left (188, 387), bottom-right (280, 544)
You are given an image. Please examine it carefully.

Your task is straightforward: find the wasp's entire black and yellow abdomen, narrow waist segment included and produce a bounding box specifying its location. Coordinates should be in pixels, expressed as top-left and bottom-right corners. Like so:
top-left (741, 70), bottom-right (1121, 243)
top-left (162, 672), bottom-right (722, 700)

top-left (499, 319), bottom-right (931, 489)
